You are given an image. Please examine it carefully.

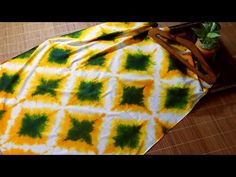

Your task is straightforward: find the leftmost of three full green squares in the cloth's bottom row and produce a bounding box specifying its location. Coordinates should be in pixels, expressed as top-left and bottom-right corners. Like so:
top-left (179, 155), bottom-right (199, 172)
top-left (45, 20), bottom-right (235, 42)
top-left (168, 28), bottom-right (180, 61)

top-left (18, 114), bottom-right (48, 138)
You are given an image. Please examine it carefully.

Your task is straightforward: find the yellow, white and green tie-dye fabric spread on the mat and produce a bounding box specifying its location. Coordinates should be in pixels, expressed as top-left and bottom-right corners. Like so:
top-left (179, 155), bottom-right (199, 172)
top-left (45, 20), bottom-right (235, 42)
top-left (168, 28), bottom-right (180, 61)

top-left (0, 22), bottom-right (209, 154)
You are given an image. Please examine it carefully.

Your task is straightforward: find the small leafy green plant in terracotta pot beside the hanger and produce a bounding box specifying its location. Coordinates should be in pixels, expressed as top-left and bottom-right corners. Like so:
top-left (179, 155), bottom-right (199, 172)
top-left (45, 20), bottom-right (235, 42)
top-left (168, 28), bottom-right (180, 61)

top-left (192, 22), bottom-right (221, 59)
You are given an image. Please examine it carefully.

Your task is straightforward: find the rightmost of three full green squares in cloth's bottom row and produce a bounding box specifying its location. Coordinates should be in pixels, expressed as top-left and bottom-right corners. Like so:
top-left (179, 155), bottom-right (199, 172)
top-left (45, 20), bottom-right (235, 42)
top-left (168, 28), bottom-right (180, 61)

top-left (113, 124), bottom-right (141, 149)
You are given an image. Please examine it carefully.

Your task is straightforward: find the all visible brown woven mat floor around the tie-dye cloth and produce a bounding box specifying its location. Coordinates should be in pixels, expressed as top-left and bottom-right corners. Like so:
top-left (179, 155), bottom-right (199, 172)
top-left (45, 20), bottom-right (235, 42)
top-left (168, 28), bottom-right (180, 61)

top-left (0, 22), bottom-right (236, 155)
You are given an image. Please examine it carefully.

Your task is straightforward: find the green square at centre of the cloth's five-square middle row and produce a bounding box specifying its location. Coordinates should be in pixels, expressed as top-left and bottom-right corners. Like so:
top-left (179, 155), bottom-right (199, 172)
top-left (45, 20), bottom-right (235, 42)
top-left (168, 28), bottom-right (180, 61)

top-left (77, 81), bottom-right (102, 101)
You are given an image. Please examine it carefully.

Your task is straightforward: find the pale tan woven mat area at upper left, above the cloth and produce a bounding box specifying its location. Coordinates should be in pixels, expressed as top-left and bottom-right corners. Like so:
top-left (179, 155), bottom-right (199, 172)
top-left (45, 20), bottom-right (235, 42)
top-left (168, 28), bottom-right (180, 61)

top-left (0, 22), bottom-right (99, 62)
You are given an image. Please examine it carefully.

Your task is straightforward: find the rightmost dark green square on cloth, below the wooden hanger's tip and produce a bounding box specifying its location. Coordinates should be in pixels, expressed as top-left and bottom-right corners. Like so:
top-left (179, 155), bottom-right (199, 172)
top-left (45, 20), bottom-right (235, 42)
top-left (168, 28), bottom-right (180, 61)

top-left (165, 87), bottom-right (189, 109)
